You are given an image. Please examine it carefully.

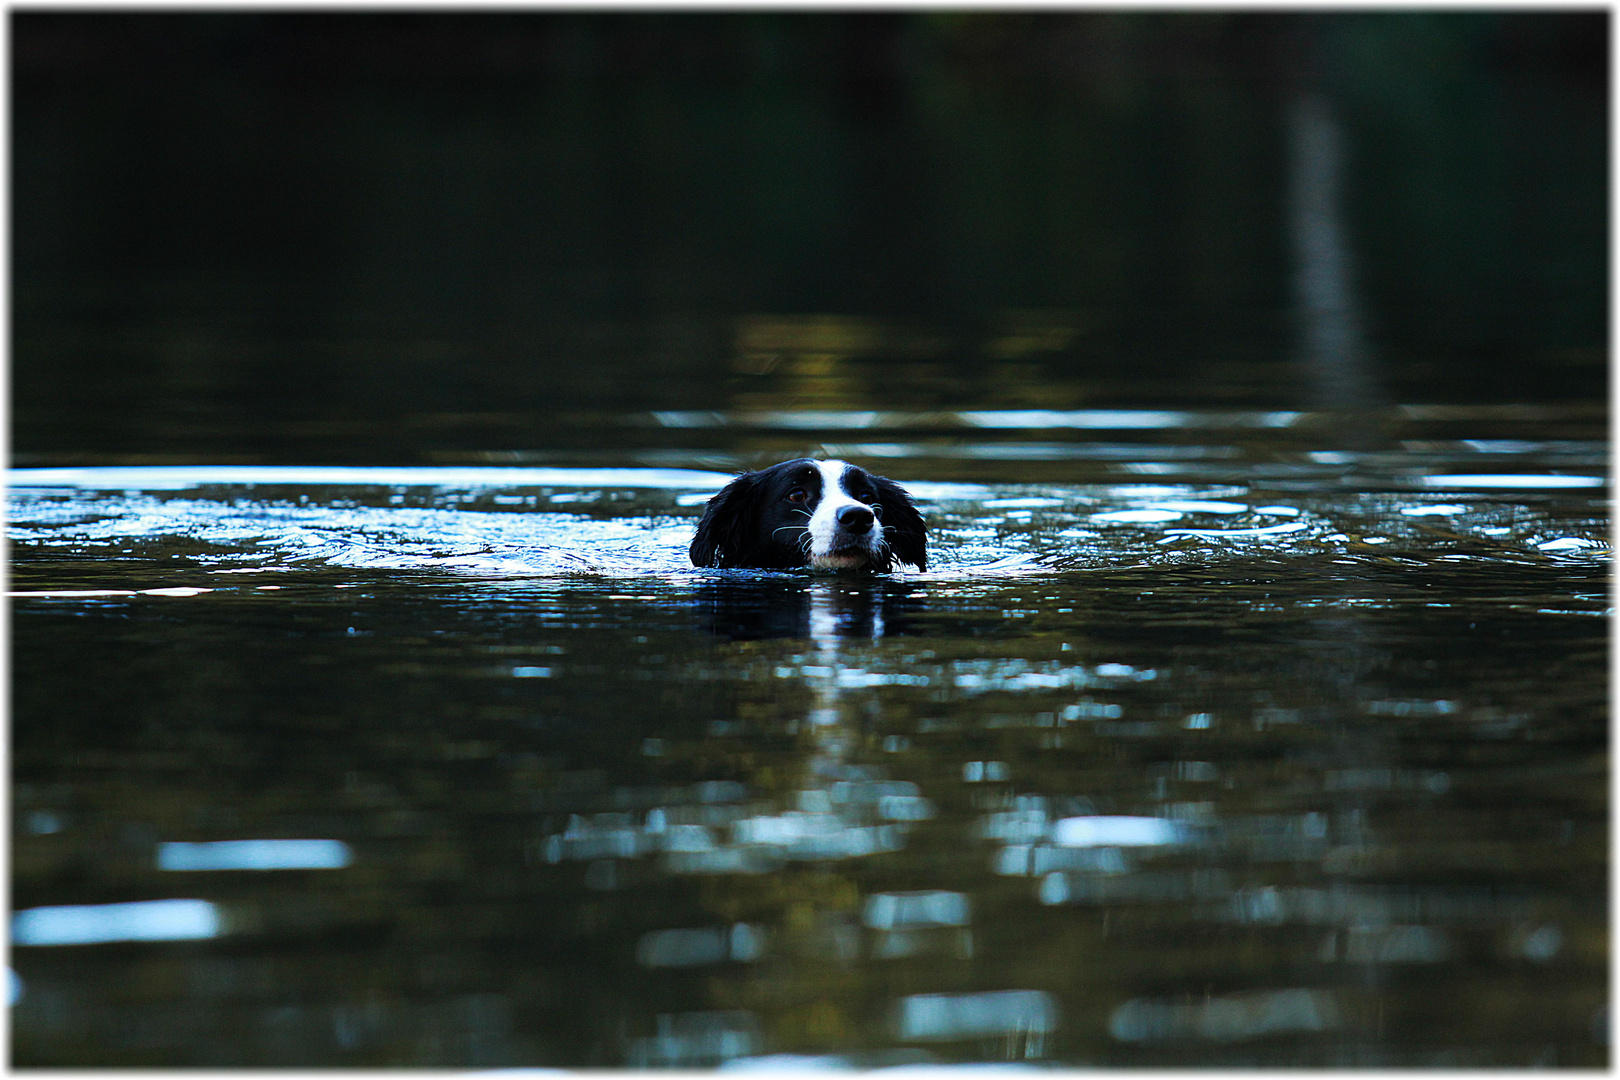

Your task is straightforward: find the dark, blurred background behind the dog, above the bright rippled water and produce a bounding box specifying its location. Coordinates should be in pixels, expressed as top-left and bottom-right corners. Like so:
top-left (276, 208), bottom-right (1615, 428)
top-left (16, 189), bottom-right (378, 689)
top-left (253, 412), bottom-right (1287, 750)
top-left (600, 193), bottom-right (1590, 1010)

top-left (11, 11), bottom-right (1609, 463)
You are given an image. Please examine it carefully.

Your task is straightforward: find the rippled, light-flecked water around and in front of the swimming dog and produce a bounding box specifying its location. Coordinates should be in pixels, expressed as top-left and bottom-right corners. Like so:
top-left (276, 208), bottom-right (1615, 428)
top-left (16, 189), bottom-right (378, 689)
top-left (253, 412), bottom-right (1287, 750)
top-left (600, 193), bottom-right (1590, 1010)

top-left (10, 433), bottom-right (1609, 1069)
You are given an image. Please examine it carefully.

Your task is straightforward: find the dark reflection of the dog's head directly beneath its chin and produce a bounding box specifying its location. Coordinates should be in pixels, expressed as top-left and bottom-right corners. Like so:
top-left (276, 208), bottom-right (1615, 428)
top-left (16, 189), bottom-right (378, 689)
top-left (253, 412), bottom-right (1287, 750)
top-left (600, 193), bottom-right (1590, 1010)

top-left (698, 575), bottom-right (922, 646)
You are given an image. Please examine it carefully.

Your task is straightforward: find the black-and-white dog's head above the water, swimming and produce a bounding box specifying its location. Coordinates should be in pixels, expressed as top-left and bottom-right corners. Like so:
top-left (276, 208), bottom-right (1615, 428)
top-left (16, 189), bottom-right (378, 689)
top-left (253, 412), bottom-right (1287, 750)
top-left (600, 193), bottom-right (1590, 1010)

top-left (692, 458), bottom-right (928, 573)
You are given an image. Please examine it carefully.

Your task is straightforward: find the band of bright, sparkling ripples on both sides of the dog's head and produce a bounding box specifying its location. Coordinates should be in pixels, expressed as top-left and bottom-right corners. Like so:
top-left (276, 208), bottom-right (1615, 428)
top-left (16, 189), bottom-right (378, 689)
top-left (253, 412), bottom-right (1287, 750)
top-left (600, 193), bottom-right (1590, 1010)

top-left (8, 466), bottom-right (1609, 578)
